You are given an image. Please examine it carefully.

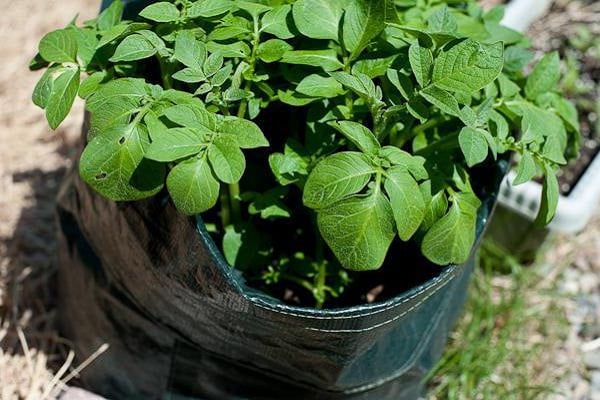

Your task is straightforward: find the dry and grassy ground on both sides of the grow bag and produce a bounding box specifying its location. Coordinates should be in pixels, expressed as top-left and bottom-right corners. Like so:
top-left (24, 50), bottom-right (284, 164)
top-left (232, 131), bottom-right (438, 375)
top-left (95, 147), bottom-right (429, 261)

top-left (0, 0), bottom-right (600, 400)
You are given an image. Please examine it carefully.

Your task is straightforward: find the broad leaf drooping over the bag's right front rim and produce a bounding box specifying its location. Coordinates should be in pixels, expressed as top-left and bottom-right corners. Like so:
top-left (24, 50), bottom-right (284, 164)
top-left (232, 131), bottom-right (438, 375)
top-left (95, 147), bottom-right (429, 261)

top-left (421, 193), bottom-right (479, 265)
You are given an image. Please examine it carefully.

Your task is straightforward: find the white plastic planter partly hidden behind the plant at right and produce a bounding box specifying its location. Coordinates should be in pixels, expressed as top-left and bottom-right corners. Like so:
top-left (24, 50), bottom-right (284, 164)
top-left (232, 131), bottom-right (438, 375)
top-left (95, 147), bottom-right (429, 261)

top-left (498, 0), bottom-right (600, 233)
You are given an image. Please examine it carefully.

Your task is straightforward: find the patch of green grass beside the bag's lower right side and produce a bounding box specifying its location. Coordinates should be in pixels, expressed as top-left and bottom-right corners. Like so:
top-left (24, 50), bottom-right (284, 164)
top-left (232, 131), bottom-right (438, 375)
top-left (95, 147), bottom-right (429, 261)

top-left (429, 240), bottom-right (567, 400)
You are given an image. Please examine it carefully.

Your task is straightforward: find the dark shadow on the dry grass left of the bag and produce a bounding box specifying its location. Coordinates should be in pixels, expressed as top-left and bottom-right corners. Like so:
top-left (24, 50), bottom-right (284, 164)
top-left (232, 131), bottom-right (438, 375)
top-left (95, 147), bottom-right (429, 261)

top-left (0, 140), bottom-right (74, 372)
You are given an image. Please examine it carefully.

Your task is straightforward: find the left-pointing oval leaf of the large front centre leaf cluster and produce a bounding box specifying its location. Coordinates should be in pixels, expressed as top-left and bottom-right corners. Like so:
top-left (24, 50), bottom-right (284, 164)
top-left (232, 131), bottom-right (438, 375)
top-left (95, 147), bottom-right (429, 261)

top-left (303, 151), bottom-right (375, 209)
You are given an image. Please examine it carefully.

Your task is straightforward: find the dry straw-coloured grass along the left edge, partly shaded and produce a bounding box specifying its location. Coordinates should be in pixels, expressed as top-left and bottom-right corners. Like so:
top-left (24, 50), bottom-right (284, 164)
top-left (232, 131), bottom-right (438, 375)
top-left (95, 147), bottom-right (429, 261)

top-left (0, 0), bottom-right (99, 400)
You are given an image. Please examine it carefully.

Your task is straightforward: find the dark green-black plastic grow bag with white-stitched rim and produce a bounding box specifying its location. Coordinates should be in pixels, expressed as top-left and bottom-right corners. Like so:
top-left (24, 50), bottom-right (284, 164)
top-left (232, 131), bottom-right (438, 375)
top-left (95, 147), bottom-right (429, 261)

top-left (58, 1), bottom-right (505, 400)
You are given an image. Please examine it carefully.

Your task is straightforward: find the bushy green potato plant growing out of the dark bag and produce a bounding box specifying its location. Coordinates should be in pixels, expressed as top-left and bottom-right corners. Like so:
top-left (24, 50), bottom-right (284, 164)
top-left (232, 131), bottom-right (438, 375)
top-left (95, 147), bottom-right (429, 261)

top-left (31, 0), bottom-right (579, 307)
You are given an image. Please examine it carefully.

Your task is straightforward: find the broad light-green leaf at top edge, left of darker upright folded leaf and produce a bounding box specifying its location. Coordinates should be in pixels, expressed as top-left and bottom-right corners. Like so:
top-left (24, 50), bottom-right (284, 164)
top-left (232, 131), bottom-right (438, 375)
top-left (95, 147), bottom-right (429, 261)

top-left (292, 0), bottom-right (343, 40)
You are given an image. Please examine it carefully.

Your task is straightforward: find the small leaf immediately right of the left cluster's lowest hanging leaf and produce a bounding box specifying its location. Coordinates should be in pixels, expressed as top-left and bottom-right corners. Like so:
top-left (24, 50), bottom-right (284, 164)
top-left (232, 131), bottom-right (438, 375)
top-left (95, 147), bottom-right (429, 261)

top-left (208, 135), bottom-right (246, 184)
